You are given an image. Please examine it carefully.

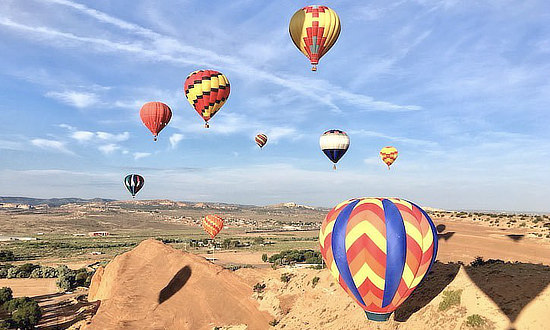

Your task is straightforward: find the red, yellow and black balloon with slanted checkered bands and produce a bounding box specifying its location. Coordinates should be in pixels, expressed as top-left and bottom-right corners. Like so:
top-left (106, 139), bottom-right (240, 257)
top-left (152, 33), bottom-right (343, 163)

top-left (183, 70), bottom-right (230, 128)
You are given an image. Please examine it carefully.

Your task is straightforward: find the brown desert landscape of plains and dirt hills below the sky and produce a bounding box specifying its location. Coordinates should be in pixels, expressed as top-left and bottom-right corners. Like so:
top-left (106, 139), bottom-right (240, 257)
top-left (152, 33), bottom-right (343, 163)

top-left (0, 198), bottom-right (550, 329)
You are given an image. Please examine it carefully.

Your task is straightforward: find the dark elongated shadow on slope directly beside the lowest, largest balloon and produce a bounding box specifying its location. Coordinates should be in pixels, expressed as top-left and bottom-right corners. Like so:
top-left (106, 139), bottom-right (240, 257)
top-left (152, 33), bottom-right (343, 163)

top-left (394, 261), bottom-right (460, 322)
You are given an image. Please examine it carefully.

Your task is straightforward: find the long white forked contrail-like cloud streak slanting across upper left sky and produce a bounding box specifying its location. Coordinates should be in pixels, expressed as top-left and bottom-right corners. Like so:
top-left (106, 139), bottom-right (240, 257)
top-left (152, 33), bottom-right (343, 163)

top-left (0, 0), bottom-right (421, 111)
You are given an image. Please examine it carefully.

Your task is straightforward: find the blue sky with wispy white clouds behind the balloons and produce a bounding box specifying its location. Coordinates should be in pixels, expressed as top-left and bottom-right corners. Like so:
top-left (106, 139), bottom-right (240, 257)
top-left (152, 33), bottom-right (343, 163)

top-left (0, 0), bottom-right (550, 211)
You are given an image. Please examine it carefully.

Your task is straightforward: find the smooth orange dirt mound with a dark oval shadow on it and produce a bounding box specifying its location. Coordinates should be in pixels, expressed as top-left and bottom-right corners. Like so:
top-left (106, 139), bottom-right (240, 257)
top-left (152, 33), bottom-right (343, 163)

top-left (86, 240), bottom-right (273, 329)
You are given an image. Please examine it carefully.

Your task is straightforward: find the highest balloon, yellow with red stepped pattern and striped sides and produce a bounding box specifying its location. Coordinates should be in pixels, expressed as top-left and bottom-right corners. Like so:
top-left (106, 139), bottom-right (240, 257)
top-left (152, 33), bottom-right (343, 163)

top-left (289, 6), bottom-right (340, 71)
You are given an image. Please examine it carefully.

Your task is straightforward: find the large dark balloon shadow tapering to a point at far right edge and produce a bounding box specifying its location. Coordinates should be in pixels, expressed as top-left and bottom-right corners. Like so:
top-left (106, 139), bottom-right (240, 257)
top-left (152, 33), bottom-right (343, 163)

top-left (464, 258), bottom-right (550, 323)
